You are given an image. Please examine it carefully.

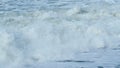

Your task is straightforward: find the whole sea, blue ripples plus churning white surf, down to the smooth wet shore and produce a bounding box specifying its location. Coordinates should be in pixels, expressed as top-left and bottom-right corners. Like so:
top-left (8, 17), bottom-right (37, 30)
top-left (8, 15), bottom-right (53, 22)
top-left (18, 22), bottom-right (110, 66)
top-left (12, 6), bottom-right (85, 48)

top-left (0, 0), bottom-right (120, 68)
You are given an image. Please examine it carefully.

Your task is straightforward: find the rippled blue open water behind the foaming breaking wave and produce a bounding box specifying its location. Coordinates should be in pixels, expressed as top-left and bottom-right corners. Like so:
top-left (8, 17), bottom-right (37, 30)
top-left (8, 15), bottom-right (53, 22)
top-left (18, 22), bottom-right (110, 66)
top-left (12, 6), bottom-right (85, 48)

top-left (0, 0), bottom-right (119, 11)
